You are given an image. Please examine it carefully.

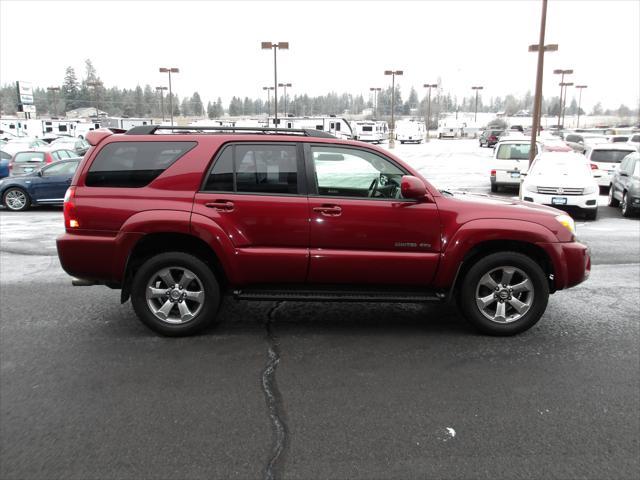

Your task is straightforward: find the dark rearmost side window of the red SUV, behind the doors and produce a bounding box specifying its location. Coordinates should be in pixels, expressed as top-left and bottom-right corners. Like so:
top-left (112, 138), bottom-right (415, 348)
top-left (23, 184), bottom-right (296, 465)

top-left (85, 142), bottom-right (197, 188)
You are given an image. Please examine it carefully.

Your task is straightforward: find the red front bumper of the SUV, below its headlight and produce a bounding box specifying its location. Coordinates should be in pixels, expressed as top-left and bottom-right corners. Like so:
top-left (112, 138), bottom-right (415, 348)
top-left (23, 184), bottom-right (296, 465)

top-left (537, 242), bottom-right (591, 290)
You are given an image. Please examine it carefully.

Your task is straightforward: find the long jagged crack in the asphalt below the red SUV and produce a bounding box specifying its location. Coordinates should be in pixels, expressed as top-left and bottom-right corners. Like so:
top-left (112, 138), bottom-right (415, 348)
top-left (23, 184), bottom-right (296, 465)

top-left (262, 301), bottom-right (288, 480)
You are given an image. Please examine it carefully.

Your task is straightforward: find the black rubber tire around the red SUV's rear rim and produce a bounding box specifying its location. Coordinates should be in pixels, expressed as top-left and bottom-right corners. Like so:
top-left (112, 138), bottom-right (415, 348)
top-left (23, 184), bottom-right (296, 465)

top-left (131, 252), bottom-right (220, 337)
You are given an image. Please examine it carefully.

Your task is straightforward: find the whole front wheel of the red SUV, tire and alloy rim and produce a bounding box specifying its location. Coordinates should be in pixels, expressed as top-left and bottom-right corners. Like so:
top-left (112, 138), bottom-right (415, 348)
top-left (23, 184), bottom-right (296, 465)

top-left (458, 252), bottom-right (549, 335)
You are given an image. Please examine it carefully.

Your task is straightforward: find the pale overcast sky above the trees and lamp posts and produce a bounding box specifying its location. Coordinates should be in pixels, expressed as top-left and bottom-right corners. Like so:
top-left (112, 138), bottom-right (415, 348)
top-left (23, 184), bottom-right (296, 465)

top-left (0, 0), bottom-right (640, 109)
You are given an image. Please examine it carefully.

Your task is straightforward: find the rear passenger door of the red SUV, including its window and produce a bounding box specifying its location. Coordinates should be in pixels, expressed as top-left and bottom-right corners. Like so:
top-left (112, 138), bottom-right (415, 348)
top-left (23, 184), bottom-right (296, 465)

top-left (193, 142), bottom-right (309, 284)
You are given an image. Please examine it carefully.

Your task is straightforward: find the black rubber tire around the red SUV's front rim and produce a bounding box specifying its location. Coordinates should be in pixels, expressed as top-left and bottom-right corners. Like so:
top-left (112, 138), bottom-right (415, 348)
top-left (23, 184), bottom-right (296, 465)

top-left (457, 252), bottom-right (549, 336)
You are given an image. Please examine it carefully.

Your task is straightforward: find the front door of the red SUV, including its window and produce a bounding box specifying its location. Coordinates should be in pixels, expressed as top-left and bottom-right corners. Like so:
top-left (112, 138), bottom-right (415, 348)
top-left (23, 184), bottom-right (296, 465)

top-left (305, 145), bottom-right (440, 285)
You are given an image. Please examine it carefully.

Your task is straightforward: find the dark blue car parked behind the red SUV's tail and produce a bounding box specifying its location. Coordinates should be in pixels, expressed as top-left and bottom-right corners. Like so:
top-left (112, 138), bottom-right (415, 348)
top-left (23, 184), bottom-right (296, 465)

top-left (0, 158), bottom-right (81, 212)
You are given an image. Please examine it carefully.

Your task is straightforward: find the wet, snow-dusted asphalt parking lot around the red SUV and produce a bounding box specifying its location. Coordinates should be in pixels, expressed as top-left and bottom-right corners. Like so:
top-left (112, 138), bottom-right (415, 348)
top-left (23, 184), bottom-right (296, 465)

top-left (0, 140), bottom-right (640, 479)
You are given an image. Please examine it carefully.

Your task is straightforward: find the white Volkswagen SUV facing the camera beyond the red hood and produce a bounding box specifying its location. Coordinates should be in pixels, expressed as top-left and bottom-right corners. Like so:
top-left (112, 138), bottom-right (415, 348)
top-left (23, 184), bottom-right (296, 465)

top-left (520, 152), bottom-right (599, 220)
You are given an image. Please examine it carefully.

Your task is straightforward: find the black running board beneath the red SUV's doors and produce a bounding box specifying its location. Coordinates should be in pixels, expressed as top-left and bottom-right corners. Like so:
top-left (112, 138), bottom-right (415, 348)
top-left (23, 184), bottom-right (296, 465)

top-left (233, 287), bottom-right (446, 303)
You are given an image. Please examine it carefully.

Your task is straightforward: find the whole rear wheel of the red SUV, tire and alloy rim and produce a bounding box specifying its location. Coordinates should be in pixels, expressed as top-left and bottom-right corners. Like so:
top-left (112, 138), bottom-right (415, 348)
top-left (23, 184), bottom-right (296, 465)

top-left (131, 252), bottom-right (220, 337)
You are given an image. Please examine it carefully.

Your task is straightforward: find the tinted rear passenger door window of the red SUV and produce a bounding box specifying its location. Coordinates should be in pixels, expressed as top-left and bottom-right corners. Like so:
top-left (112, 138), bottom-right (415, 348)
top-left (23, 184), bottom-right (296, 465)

top-left (205, 144), bottom-right (298, 194)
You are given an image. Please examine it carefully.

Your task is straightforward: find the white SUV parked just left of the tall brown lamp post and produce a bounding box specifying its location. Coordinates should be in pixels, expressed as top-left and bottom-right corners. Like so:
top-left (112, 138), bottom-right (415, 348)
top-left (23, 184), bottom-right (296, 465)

top-left (489, 137), bottom-right (539, 192)
